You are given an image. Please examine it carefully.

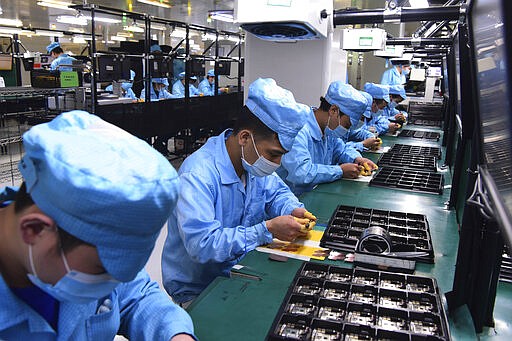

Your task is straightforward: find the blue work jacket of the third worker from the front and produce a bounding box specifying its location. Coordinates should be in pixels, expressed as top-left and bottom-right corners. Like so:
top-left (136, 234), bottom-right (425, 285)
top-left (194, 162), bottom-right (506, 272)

top-left (277, 110), bottom-right (361, 196)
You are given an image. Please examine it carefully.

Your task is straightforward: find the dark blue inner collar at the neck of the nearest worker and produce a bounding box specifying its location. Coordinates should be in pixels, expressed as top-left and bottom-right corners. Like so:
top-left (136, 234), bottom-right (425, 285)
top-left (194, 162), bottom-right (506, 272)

top-left (0, 275), bottom-right (55, 334)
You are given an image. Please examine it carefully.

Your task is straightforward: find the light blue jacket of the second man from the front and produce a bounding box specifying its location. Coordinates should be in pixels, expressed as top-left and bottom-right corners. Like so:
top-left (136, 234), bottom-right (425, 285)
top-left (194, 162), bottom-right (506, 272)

top-left (162, 129), bottom-right (304, 303)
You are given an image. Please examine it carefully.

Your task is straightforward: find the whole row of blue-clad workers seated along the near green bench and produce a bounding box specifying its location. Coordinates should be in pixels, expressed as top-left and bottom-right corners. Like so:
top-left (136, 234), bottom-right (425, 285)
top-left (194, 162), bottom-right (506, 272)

top-left (0, 49), bottom-right (412, 341)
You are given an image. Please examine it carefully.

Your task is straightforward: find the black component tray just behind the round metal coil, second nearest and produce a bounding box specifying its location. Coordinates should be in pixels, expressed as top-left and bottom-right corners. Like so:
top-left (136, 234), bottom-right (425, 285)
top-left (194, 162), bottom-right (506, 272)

top-left (320, 205), bottom-right (434, 263)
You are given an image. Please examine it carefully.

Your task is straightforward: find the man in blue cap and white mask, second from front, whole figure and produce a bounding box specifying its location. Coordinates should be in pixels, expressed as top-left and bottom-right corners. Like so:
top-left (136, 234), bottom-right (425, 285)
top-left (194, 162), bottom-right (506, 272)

top-left (162, 78), bottom-right (316, 303)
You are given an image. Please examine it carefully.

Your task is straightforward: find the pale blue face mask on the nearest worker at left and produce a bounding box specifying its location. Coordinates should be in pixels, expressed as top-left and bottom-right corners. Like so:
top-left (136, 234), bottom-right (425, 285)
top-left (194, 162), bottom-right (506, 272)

top-left (27, 245), bottom-right (119, 304)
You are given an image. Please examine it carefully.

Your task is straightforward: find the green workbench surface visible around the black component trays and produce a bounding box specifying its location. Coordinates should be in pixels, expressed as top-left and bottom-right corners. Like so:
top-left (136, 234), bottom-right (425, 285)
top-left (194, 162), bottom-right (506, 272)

top-left (187, 125), bottom-right (512, 341)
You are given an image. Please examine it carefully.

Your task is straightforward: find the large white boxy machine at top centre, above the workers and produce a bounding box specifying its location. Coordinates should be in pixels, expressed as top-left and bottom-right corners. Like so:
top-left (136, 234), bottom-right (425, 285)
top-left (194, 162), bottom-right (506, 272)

top-left (235, 0), bottom-right (347, 105)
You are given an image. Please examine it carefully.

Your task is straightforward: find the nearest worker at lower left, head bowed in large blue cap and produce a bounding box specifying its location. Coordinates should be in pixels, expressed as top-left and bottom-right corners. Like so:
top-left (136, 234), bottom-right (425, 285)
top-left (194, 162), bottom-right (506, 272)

top-left (0, 111), bottom-right (193, 341)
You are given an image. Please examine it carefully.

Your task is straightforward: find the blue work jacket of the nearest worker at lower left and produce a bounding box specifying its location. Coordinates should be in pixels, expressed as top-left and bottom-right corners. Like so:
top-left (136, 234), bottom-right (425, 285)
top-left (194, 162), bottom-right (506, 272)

top-left (0, 187), bottom-right (194, 341)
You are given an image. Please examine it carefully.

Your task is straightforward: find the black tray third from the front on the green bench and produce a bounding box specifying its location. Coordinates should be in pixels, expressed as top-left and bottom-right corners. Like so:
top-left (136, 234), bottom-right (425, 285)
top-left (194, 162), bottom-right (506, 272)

top-left (370, 167), bottom-right (444, 194)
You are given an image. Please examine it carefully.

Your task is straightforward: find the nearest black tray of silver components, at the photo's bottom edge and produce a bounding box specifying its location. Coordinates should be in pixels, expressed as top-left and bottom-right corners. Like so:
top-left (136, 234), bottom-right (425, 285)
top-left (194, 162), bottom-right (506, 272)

top-left (267, 262), bottom-right (450, 341)
